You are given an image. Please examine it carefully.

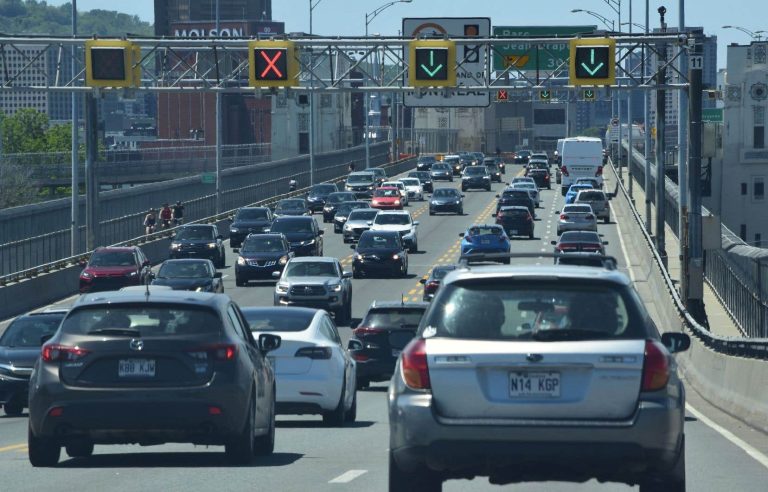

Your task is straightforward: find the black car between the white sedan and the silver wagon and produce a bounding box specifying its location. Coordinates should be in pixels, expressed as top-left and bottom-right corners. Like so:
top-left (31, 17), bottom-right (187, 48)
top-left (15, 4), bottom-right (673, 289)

top-left (350, 301), bottom-right (429, 388)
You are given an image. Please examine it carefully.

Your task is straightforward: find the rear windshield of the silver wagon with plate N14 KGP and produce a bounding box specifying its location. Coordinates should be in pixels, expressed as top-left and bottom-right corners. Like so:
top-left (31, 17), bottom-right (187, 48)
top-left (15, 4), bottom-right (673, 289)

top-left (419, 279), bottom-right (646, 341)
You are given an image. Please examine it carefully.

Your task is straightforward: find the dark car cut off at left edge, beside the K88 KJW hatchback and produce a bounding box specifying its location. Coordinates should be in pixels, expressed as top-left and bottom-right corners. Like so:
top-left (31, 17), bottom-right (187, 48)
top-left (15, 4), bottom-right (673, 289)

top-left (0, 309), bottom-right (67, 417)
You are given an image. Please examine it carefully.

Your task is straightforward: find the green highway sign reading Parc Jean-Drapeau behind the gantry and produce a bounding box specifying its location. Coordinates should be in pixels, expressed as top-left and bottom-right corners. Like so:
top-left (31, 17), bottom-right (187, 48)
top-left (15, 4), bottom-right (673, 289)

top-left (493, 26), bottom-right (597, 71)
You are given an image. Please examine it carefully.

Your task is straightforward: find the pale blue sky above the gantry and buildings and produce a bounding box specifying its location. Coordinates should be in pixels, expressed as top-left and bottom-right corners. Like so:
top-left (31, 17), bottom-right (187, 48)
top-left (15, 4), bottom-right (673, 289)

top-left (48, 0), bottom-right (768, 68)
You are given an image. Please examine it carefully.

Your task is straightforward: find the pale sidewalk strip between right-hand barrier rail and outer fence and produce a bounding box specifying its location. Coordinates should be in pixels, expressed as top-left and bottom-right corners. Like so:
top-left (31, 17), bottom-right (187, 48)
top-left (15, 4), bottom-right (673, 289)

top-left (607, 168), bottom-right (744, 338)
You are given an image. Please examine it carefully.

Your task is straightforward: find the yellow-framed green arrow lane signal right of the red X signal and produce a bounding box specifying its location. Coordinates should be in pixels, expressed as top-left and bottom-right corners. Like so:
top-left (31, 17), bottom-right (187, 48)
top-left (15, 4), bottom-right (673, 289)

top-left (408, 40), bottom-right (456, 87)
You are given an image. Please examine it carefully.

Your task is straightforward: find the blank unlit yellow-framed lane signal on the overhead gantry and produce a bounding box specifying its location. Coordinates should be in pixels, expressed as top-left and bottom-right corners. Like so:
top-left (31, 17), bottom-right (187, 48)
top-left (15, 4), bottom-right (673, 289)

top-left (85, 39), bottom-right (141, 87)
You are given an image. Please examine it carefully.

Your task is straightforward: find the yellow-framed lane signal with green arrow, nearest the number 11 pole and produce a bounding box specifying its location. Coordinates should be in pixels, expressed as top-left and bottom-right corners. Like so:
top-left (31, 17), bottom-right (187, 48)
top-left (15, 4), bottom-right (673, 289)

top-left (569, 38), bottom-right (616, 85)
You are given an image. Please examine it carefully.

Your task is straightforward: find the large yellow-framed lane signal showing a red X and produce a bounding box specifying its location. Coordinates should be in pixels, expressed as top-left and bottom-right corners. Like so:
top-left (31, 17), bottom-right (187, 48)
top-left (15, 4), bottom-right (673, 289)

top-left (248, 41), bottom-right (299, 87)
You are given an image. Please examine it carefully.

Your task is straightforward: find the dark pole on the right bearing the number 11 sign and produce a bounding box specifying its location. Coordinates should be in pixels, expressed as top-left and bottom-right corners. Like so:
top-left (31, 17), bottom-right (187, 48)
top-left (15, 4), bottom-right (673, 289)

top-left (681, 34), bottom-right (706, 320)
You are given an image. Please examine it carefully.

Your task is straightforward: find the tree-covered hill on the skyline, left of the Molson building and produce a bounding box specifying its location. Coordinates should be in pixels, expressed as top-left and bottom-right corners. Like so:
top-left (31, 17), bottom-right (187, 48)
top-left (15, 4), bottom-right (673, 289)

top-left (0, 0), bottom-right (154, 36)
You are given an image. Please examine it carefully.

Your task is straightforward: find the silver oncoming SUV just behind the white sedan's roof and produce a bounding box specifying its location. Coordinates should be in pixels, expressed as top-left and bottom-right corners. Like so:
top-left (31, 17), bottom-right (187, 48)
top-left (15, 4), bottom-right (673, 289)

top-left (273, 257), bottom-right (352, 325)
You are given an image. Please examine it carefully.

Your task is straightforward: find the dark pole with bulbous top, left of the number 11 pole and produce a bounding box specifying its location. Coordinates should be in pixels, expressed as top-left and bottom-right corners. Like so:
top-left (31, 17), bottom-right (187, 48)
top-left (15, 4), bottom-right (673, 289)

top-left (656, 6), bottom-right (667, 268)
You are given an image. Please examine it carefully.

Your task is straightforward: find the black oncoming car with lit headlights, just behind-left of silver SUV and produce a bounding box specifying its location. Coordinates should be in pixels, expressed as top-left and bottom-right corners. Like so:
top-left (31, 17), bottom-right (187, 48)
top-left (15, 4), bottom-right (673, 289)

top-left (235, 233), bottom-right (294, 287)
